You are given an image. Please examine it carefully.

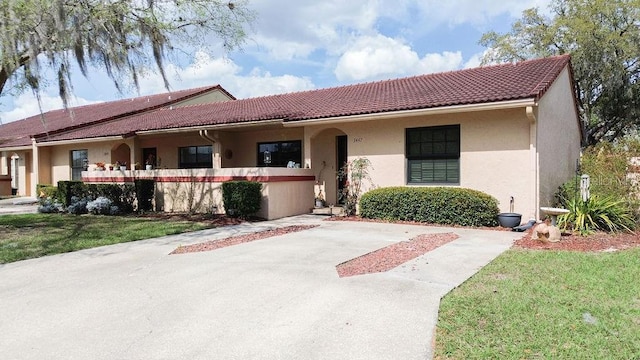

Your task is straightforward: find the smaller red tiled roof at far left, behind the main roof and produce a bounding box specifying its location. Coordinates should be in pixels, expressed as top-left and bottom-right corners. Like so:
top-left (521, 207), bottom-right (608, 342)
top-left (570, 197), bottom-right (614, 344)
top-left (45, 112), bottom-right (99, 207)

top-left (0, 85), bottom-right (231, 147)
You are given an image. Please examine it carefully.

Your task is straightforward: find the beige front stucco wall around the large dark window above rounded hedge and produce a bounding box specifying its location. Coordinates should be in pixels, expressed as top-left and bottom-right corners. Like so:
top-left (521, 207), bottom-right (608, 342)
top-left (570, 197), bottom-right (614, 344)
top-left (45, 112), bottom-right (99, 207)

top-left (307, 108), bottom-right (533, 218)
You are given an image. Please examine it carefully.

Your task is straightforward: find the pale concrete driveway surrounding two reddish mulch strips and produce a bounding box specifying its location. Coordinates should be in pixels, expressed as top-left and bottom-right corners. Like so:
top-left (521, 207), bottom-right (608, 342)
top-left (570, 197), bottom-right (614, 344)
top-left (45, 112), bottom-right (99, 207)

top-left (0, 216), bottom-right (521, 360)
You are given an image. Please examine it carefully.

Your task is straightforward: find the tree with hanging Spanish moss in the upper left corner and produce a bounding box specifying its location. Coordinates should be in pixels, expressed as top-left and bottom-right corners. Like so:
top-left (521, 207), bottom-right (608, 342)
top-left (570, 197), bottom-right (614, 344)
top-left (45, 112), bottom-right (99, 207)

top-left (0, 0), bottom-right (254, 112)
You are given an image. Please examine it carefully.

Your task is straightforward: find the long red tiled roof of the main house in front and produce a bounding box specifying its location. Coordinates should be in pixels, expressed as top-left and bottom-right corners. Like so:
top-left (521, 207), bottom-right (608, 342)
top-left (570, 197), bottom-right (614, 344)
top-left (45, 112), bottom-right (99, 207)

top-left (10, 55), bottom-right (570, 146)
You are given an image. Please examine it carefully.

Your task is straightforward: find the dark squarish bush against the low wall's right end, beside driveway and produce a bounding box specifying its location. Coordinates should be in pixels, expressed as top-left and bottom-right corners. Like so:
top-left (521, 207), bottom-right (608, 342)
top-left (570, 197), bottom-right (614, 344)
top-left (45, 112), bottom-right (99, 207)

top-left (222, 181), bottom-right (262, 218)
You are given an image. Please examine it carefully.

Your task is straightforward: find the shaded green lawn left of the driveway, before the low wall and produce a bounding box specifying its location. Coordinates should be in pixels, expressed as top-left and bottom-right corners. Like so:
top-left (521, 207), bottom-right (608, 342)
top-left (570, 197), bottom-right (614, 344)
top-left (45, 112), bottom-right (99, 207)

top-left (0, 214), bottom-right (209, 264)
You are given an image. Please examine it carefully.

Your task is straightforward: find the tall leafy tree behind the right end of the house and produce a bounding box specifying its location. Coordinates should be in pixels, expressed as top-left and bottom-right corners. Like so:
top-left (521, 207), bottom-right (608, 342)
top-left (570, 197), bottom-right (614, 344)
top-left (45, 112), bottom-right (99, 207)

top-left (480, 0), bottom-right (640, 144)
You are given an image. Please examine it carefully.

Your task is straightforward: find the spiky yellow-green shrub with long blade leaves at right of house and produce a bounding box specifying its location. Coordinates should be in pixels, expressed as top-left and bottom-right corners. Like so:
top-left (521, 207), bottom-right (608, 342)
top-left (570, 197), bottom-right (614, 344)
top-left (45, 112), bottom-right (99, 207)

top-left (558, 194), bottom-right (635, 235)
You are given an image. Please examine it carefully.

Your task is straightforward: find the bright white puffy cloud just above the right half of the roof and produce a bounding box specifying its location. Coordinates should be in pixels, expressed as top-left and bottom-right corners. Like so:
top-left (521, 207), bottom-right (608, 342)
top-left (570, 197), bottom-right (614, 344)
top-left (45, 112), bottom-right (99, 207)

top-left (334, 35), bottom-right (462, 81)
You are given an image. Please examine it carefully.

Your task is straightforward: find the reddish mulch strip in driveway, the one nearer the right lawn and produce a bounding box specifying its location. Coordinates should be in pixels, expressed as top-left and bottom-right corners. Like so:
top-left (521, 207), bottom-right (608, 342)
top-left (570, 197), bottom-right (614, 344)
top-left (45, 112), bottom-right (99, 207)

top-left (336, 233), bottom-right (458, 277)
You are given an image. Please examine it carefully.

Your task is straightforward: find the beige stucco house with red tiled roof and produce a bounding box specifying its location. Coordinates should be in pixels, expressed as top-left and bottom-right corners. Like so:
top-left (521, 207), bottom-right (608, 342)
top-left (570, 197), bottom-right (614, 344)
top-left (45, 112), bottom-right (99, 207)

top-left (0, 55), bottom-right (582, 218)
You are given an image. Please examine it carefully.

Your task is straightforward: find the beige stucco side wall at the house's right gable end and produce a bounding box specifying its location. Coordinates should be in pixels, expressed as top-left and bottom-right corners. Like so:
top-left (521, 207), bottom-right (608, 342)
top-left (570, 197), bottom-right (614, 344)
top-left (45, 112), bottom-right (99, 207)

top-left (537, 69), bottom-right (580, 210)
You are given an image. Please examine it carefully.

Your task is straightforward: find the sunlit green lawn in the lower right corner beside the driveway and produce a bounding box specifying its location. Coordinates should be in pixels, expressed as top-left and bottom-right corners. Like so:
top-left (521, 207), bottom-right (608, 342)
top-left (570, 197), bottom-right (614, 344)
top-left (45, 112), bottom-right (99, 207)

top-left (435, 248), bottom-right (640, 359)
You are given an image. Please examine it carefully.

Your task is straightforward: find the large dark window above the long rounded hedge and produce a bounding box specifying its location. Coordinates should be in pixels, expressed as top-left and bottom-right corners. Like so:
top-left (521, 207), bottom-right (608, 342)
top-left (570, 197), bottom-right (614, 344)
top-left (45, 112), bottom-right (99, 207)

top-left (406, 125), bottom-right (460, 184)
